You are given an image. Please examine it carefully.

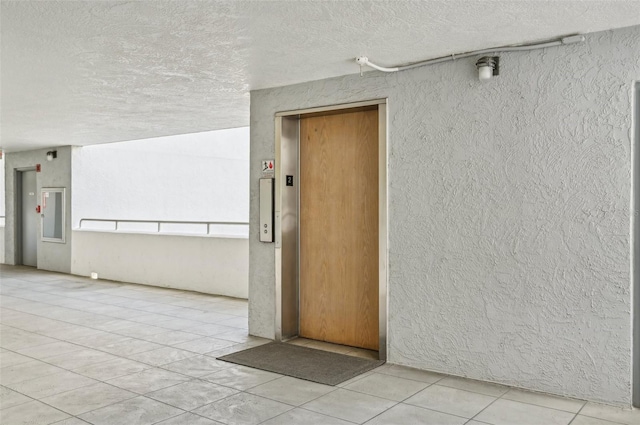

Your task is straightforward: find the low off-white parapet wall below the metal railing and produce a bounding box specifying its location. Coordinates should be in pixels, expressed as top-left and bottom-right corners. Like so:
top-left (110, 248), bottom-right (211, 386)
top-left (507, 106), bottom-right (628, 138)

top-left (71, 230), bottom-right (249, 298)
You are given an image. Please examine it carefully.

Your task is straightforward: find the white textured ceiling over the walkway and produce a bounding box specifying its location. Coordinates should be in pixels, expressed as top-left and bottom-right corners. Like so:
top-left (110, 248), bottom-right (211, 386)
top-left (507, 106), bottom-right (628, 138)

top-left (0, 0), bottom-right (640, 151)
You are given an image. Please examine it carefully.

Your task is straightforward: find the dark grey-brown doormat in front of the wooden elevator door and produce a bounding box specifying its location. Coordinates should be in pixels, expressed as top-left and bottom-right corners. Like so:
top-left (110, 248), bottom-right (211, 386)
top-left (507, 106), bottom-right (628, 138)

top-left (218, 342), bottom-right (384, 385)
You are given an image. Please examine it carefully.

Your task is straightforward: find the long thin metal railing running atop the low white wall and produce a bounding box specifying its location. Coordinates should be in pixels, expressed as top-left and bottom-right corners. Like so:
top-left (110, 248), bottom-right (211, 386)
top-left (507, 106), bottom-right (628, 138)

top-left (78, 218), bottom-right (249, 238)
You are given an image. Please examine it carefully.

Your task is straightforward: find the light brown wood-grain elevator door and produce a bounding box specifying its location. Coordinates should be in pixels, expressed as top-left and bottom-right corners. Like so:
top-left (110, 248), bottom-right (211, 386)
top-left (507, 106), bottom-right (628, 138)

top-left (299, 107), bottom-right (379, 350)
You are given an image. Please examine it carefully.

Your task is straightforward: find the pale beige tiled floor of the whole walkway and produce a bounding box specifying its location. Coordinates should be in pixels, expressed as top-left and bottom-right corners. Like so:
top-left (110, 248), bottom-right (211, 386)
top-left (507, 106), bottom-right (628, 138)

top-left (0, 266), bottom-right (640, 425)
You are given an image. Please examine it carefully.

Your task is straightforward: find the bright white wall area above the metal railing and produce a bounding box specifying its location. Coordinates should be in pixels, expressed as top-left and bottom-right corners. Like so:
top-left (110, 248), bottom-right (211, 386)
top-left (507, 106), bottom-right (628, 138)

top-left (73, 127), bottom-right (249, 224)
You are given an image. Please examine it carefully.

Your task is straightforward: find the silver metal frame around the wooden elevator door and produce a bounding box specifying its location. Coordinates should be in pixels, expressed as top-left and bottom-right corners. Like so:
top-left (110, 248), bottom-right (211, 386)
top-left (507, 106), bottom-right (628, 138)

top-left (275, 99), bottom-right (388, 360)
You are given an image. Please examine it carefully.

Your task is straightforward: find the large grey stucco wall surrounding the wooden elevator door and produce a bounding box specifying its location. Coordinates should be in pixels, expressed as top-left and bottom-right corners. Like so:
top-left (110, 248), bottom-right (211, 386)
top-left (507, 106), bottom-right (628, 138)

top-left (249, 27), bottom-right (640, 405)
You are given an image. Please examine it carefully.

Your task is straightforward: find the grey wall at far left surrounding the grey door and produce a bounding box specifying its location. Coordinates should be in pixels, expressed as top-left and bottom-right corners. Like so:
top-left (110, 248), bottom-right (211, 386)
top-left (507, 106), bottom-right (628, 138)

top-left (4, 146), bottom-right (73, 273)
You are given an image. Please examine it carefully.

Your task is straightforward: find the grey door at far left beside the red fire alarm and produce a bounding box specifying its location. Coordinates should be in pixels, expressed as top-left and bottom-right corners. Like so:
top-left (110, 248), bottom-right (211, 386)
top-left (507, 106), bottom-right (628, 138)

top-left (20, 171), bottom-right (40, 267)
